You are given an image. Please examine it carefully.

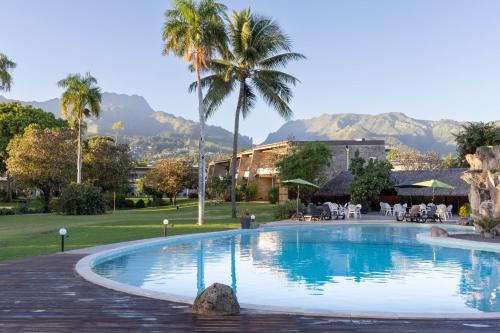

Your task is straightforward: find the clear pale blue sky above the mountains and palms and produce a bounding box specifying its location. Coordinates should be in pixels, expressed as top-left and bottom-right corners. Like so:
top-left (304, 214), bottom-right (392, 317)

top-left (0, 0), bottom-right (500, 143)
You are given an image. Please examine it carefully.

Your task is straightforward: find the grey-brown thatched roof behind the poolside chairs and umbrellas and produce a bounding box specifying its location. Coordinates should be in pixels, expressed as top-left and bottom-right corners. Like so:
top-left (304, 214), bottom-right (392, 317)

top-left (316, 168), bottom-right (469, 196)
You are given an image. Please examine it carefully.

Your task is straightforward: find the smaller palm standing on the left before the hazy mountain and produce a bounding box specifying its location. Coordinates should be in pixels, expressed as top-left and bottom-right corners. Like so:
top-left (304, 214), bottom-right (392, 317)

top-left (57, 73), bottom-right (102, 184)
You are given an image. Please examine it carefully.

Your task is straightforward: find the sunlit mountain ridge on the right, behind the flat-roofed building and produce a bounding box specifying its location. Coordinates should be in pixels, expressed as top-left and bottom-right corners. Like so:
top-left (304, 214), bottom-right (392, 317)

top-left (263, 113), bottom-right (480, 154)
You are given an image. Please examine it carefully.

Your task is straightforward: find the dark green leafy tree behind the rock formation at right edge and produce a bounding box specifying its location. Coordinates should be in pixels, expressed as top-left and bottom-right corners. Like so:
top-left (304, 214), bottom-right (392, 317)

top-left (454, 122), bottom-right (500, 166)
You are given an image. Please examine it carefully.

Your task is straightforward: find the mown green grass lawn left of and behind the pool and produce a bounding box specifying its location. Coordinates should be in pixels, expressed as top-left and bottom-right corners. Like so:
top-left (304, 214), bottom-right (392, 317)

top-left (0, 201), bottom-right (274, 260)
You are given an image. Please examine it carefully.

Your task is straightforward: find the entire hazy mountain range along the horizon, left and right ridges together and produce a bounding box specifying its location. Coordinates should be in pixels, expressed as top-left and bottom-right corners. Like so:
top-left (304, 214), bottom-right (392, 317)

top-left (0, 93), bottom-right (494, 159)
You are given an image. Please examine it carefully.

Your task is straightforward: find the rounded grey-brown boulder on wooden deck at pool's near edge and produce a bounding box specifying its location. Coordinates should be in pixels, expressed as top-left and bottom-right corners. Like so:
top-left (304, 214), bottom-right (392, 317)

top-left (193, 283), bottom-right (240, 316)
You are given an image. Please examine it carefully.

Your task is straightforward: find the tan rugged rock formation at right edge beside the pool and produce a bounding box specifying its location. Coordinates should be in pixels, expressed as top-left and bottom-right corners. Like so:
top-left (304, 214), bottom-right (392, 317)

top-left (462, 146), bottom-right (500, 220)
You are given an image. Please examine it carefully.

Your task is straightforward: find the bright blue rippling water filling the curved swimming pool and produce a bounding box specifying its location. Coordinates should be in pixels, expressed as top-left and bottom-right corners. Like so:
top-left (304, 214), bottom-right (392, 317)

top-left (93, 225), bottom-right (500, 313)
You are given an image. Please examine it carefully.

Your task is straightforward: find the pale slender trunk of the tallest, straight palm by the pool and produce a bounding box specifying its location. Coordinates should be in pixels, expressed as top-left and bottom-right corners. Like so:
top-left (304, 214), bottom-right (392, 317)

top-left (196, 69), bottom-right (205, 225)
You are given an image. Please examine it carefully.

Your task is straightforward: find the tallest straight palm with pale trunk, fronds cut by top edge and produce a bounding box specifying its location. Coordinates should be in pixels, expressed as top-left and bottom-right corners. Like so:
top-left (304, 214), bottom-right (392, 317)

top-left (163, 0), bottom-right (227, 225)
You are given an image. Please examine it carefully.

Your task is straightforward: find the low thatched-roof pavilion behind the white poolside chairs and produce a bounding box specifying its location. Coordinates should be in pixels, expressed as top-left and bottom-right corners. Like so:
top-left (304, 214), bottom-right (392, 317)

top-left (313, 168), bottom-right (469, 208)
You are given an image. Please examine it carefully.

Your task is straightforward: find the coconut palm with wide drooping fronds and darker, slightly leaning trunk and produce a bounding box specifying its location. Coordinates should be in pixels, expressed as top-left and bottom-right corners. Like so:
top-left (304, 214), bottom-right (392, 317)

top-left (199, 9), bottom-right (305, 218)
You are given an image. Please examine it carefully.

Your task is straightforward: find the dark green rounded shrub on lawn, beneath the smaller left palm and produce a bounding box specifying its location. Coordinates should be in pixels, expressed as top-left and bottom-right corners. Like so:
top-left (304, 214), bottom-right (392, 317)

top-left (60, 183), bottom-right (106, 215)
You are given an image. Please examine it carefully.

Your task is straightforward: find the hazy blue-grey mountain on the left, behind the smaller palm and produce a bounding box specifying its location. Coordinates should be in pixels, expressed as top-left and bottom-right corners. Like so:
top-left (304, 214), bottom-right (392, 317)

top-left (0, 93), bottom-right (252, 159)
